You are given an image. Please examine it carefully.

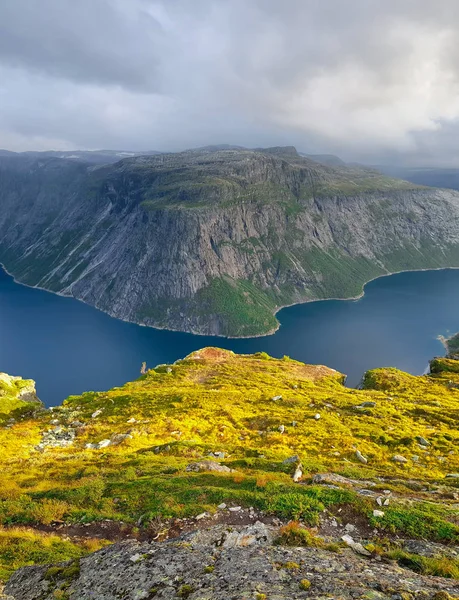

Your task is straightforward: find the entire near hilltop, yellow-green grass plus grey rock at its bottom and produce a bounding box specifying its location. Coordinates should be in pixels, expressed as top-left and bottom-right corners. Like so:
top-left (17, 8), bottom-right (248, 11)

top-left (0, 348), bottom-right (459, 600)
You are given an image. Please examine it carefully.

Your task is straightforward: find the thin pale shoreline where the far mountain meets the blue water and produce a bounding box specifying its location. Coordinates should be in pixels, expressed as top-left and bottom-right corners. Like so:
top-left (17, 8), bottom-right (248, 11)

top-left (0, 262), bottom-right (459, 340)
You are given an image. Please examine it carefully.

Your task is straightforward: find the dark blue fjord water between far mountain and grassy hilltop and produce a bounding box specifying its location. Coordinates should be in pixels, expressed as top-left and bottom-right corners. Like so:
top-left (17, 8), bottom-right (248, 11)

top-left (0, 270), bottom-right (459, 406)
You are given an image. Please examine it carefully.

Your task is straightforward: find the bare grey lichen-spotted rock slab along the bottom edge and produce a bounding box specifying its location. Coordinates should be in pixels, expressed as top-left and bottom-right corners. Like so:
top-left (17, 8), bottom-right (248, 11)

top-left (5, 523), bottom-right (459, 600)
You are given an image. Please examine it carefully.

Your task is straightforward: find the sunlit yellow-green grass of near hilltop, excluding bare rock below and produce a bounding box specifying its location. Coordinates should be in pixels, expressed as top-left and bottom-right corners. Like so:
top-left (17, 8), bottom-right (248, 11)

top-left (0, 348), bottom-right (459, 580)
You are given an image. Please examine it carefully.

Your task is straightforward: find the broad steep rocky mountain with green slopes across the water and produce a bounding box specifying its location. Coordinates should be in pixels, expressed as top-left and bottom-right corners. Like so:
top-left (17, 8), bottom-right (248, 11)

top-left (0, 147), bottom-right (459, 336)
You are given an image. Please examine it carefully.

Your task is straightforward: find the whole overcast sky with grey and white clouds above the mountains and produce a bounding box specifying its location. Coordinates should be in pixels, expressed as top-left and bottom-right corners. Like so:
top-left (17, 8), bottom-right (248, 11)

top-left (0, 0), bottom-right (459, 166)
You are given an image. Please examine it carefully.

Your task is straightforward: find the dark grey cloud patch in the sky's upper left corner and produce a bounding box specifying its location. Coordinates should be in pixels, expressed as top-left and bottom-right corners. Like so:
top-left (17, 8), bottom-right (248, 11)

top-left (0, 0), bottom-right (162, 90)
